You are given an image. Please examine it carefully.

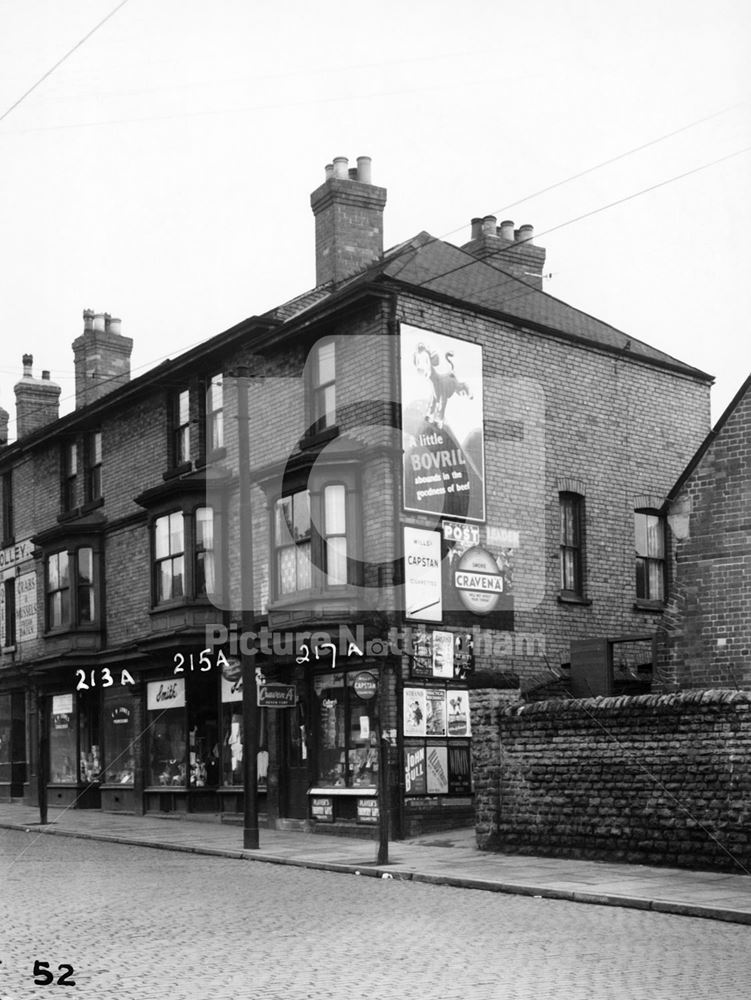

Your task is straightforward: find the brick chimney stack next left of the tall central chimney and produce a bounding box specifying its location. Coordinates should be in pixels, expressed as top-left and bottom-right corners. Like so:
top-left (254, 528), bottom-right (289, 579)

top-left (73, 309), bottom-right (133, 410)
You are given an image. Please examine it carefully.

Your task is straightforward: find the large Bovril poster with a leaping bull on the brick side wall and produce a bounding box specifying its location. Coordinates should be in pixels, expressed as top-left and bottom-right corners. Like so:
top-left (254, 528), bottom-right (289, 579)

top-left (400, 324), bottom-right (485, 521)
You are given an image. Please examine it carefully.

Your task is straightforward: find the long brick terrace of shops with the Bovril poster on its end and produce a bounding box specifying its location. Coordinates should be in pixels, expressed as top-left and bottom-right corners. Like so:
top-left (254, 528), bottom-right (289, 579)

top-left (0, 158), bottom-right (711, 835)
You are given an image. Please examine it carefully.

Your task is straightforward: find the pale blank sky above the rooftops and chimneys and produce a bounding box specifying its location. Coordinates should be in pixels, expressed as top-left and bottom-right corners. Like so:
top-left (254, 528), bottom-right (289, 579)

top-left (0, 0), bottom-right (751, 439)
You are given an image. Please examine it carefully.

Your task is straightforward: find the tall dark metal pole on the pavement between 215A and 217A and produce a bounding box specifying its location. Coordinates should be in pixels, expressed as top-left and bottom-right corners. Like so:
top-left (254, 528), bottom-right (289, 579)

top-left (236, 368), bottom-right (258, 851)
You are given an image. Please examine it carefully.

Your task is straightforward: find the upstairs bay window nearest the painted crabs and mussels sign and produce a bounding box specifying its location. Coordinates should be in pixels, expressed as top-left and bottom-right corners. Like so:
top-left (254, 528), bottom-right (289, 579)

top-left (45, 546), bottom-right (98, 630)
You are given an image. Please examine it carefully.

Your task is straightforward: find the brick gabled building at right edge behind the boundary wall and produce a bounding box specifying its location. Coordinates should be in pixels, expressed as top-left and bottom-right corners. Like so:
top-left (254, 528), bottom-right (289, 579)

top-left (658, 376), bottom-right (751, 688)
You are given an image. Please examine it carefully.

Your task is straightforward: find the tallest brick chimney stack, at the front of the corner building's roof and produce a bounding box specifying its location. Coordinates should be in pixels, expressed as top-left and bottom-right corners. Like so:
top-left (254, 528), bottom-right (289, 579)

top-left (310, 156), bottom-right (386, 285)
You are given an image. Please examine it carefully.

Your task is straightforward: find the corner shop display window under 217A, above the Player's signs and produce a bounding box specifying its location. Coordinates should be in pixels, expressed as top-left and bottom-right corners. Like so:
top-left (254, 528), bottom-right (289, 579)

top-left (314, 671), bottom-right (378, 788)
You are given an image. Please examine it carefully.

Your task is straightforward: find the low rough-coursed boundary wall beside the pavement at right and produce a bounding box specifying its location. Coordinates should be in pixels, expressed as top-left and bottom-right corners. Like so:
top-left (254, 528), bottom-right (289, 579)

top-left (472, 690), bottom-right (751, 874)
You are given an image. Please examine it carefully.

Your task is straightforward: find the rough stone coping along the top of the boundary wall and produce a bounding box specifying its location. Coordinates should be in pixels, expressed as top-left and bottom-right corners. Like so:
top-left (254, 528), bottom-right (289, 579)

top-left (502, 688), bottom-right (751, 717)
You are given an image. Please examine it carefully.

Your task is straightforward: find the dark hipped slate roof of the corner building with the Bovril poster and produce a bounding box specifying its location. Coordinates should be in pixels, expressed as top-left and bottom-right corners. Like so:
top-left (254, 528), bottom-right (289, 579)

top-left (268, 232), bottom-right (712, 381)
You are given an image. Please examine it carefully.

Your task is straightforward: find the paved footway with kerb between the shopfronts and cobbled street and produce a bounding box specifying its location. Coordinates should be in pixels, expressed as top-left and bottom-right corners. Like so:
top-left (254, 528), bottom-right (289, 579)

top-left (0, 803), bottom-right (751, 924)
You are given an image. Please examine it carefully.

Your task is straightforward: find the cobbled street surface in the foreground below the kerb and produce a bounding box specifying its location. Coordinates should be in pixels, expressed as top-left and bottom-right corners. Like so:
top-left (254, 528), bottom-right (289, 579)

top-left (0, 831), bottom-right (751, 1000)
